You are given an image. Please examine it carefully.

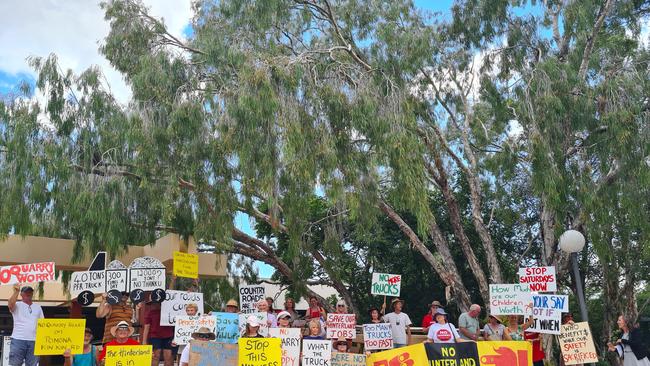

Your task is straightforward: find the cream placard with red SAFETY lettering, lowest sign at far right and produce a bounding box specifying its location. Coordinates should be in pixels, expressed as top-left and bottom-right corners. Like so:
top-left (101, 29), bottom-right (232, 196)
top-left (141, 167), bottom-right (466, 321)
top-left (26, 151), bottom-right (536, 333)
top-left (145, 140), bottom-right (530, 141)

top-left (558, 322), bottom-right (598, 365)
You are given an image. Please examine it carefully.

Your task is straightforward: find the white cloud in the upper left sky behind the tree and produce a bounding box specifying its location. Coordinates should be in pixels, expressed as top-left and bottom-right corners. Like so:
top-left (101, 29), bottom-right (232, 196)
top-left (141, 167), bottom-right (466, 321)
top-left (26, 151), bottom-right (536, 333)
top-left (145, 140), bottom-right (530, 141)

top-left (0, 0), bottom-right (192, 103)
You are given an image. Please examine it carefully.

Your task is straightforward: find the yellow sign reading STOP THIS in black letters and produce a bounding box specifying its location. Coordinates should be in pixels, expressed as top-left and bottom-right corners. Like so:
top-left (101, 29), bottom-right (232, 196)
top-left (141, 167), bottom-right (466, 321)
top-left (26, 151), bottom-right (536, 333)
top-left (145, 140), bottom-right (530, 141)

top-left (239, 338), bottom-right (282, 366)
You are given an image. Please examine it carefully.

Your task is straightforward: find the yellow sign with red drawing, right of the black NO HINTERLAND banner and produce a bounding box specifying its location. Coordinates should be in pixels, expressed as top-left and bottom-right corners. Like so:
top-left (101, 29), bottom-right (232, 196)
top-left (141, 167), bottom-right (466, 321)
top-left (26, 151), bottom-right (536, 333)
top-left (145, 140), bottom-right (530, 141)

top-left (476, 341), bottom-right (533, 366)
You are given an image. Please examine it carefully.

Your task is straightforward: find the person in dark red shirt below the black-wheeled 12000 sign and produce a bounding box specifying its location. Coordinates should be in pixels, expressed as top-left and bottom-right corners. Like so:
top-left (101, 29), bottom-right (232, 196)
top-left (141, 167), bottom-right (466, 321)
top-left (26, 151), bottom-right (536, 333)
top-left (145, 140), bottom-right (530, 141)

top-left (142, 302), bottom-right (178, 366)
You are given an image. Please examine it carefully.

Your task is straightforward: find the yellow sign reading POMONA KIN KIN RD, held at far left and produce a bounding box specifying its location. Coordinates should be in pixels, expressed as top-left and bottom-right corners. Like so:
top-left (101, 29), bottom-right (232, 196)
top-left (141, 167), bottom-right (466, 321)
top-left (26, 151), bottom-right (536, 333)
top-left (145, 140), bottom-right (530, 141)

top-left (34, 319), bottom-right (86, 356)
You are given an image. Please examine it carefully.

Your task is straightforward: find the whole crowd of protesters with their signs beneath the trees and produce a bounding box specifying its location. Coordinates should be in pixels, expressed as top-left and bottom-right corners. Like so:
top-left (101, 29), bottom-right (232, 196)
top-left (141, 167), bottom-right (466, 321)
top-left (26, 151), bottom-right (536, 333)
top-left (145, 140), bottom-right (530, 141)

top-left (2, 258), bottom-right (650, 366)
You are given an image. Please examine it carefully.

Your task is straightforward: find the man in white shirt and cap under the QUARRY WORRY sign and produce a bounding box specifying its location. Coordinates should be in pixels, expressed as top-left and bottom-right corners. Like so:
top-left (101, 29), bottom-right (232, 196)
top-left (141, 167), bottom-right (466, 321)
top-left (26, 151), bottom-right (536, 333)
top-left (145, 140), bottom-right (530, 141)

top-left (7, 283), bottom-right (44, 366)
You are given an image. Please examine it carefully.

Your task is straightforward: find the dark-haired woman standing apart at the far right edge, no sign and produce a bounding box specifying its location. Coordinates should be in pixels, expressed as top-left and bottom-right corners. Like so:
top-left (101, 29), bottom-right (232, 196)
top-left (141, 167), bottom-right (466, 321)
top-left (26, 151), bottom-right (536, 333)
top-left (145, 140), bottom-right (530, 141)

top-left (607, 315), bottom-right (650, 366)
